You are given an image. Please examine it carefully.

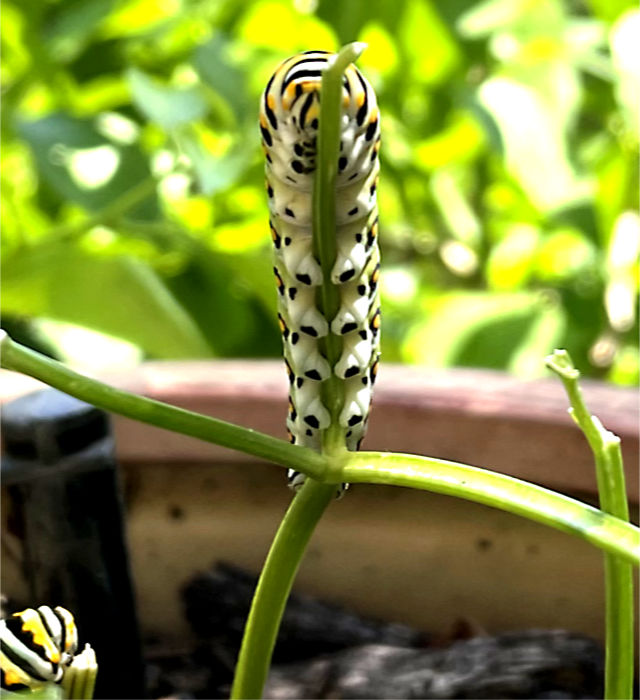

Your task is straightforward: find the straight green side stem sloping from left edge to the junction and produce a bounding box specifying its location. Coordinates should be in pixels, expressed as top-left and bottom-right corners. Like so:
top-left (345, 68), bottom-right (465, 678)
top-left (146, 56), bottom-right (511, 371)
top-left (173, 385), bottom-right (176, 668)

top-left (0, 331), bottom-right (325, 477)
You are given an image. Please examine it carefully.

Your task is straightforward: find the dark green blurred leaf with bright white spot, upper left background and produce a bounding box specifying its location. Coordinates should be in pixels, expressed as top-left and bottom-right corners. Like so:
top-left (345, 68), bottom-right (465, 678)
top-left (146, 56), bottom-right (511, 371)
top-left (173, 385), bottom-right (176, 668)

top-left (18, 114), bottom-right (158, 219)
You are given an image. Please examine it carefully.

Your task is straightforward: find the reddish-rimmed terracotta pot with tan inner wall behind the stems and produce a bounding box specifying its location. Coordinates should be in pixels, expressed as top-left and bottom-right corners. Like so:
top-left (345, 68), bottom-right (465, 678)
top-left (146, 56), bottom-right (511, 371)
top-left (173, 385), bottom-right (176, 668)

top-left (2, 361), bottom-right (638, 641)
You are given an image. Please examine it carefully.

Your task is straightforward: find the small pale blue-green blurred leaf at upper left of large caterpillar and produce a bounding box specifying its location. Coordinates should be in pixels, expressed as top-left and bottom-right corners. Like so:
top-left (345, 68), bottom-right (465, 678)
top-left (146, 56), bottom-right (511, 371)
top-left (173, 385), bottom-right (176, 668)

top-left (127, 68), bottom-right (208, 131)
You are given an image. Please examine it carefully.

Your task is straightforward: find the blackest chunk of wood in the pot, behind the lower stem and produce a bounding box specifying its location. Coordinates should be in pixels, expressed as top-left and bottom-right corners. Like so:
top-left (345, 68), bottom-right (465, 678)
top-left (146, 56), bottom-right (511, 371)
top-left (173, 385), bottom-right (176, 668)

top-left (174, 563), bottom-right (427, 698)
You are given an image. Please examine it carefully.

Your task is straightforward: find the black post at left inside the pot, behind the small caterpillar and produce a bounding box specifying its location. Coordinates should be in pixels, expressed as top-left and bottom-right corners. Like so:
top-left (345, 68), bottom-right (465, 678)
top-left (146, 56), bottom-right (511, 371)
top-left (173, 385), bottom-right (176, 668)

top-left (2, 389), bottom-right (144, 698)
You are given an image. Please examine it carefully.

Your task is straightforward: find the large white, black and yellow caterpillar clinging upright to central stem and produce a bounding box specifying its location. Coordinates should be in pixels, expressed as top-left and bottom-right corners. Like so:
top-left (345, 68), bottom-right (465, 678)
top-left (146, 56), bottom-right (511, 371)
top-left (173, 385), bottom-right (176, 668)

top-left (260, 51), bottom-right (380, 488)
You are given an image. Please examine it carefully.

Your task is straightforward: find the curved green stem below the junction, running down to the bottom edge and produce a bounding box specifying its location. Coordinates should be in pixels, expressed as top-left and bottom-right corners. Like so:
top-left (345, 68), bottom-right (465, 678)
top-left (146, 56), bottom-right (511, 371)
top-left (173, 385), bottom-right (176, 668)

top-left (231, 479), bottom-right (336, 698)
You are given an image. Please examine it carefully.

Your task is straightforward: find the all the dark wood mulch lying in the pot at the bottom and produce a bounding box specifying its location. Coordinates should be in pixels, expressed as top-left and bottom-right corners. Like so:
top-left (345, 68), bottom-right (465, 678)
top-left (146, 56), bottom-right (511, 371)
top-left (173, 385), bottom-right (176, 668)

top-left (148, 564), bottom-right (603, 700)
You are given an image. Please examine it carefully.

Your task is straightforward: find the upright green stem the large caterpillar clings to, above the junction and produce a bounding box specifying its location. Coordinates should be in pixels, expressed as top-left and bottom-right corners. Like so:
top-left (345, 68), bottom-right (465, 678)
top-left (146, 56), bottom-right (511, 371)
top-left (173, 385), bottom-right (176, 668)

top-left (312, 42), bottom-right (366, 454)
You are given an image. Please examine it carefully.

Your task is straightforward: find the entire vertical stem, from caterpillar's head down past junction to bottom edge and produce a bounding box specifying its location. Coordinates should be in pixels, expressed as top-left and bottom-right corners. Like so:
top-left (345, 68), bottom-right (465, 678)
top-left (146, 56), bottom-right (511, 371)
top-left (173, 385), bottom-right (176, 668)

top-left (231, 43), bottom-right (365, 698)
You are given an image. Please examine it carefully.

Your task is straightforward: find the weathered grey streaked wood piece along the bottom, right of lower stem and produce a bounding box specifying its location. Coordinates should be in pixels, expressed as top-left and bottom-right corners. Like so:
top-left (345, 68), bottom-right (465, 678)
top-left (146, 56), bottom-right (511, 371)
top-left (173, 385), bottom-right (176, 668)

top-left (263, 630), bottom-right (603, 700)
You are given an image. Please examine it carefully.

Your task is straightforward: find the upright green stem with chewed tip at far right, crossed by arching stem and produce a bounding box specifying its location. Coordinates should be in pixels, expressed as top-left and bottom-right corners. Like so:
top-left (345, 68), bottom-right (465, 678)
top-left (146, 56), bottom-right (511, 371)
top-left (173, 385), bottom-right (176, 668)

top-left (546, 350), bottom-right (634, 700)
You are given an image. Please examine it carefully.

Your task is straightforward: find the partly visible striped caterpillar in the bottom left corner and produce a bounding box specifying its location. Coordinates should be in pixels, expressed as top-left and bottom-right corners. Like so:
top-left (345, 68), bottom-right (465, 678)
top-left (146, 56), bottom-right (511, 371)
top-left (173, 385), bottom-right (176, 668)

top-left (0, 605), bottom-right (78, 690)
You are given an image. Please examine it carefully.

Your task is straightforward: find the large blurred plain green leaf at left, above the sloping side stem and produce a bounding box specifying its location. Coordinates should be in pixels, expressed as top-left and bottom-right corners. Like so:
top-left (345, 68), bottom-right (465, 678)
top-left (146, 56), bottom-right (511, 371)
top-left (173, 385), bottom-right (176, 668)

top-left (2, 242), bottom-right (211, 359)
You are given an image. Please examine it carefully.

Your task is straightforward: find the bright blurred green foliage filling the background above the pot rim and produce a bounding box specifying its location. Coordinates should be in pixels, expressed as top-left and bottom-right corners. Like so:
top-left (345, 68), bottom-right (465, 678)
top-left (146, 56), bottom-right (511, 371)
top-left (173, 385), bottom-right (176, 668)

top-left (2, 0), bottom-right (640, 383)
